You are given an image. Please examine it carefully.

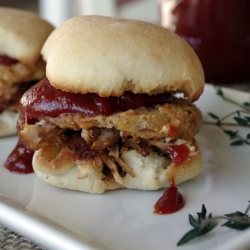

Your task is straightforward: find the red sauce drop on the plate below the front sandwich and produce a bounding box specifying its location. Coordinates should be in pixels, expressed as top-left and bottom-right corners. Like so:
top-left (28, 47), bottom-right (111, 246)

top-left (154, 179), bottom-right (185, 214)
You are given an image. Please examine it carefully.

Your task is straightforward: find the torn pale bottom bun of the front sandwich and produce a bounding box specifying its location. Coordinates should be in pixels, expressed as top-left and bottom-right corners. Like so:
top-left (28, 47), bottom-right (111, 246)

top-left (33, 141), bottom-right (202, 194)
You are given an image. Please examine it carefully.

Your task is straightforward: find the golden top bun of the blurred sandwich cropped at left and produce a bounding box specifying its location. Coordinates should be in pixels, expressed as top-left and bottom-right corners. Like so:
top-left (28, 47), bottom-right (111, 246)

top-left (0, 7), bottom-right (54, 66)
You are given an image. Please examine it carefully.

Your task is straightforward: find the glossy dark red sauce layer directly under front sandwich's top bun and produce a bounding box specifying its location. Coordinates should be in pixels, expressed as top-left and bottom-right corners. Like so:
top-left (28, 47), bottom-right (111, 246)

top-left (21, 78), bottom-right (171, 120)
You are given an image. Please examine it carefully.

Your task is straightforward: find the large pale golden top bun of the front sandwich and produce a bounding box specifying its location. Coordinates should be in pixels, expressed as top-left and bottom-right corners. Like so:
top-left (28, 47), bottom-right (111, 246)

top-left (41, 16), bottom-right (204, 102)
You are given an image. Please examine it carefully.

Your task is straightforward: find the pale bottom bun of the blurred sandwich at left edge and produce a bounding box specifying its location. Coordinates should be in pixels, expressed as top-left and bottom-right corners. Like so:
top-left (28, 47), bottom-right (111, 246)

top-left (0, 110), bottom-right (19, 137)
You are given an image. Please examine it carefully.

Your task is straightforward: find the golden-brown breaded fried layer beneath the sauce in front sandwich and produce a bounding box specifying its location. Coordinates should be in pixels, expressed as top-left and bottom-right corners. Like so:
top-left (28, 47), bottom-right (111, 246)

top-left (42, 98), bottom-right (202, 140)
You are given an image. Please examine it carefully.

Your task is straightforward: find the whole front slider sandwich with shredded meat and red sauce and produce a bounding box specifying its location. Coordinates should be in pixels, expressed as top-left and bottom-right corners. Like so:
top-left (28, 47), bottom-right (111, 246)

top-left (18, 16), bottom-right (204, 193)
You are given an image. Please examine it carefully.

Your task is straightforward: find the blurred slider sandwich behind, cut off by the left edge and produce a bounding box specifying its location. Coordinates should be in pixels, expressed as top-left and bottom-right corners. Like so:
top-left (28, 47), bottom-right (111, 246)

top-left (0, 7), bottom-right (54, 137)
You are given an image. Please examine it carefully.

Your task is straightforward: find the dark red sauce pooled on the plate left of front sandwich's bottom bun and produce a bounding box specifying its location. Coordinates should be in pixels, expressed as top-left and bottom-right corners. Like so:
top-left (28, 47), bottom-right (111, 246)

top-left (4, 138), bottom-right (34, 174)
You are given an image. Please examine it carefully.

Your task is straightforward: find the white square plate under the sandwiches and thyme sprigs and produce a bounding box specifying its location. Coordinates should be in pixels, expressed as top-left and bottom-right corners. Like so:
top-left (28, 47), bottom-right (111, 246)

top-left (0, 85), bottom-right (250, 250)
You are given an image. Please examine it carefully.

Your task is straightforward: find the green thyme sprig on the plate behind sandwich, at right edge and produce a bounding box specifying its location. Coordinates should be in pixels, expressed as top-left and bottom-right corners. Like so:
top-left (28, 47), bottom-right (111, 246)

top-left (204, 87), bottom-right (250, 146)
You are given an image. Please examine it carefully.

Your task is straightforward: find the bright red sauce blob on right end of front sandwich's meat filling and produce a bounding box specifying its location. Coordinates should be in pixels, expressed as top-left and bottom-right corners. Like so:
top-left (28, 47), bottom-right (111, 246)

top-left (167, 144), bottom-right (190, 166)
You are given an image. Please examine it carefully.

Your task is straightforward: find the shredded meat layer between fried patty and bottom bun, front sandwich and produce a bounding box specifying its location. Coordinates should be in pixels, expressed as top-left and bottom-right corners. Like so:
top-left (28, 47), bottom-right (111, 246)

top-left (21, 120), bottom-right (199, 185)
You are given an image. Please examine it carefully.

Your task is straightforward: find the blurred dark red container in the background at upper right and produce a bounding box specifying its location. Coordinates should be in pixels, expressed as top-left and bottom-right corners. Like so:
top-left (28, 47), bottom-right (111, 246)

top-left (160, 0), bottom-right (250, 83)
